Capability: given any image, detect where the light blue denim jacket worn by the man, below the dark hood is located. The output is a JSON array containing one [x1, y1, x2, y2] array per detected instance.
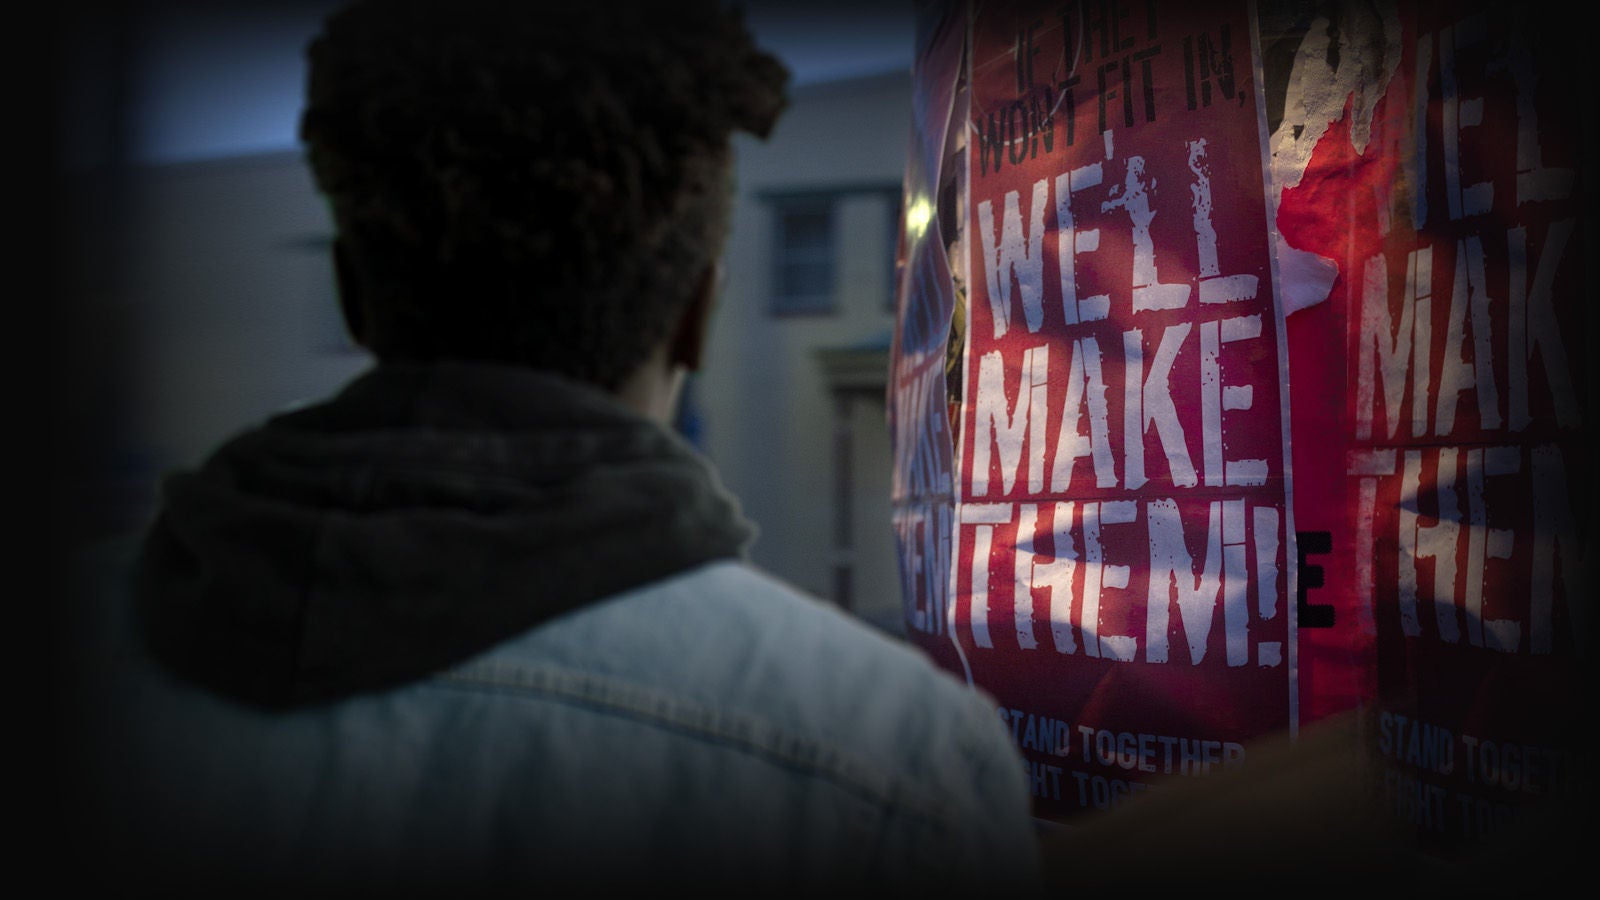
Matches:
[[75, 531, 1038, 895]]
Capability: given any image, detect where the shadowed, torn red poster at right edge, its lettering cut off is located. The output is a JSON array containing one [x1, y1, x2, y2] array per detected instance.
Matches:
[[1274, 3, 1595, 850]]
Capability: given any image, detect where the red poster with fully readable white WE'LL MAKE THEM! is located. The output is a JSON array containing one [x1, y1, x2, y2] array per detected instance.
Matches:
[[896, 2, 1298, 818]]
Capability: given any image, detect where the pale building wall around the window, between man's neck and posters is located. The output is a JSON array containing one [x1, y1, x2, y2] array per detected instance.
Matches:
[[701, 70, 910, 630]]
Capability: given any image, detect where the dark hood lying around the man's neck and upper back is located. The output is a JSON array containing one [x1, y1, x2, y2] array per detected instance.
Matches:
[[136, 364, 754, 708]]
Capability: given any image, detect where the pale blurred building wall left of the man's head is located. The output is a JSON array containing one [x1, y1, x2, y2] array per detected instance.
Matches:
[[117, 154, 370, 466]]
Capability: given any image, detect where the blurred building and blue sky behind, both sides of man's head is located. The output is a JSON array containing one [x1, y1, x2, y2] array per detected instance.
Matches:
[[46, 0, 915, 633]]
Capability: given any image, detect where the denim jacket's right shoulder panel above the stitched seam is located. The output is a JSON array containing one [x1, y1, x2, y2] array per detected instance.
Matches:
[[467, 560, 997, 761]]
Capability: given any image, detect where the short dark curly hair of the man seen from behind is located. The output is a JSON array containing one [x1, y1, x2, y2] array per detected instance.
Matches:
[[299, 0, 789, 389]]
